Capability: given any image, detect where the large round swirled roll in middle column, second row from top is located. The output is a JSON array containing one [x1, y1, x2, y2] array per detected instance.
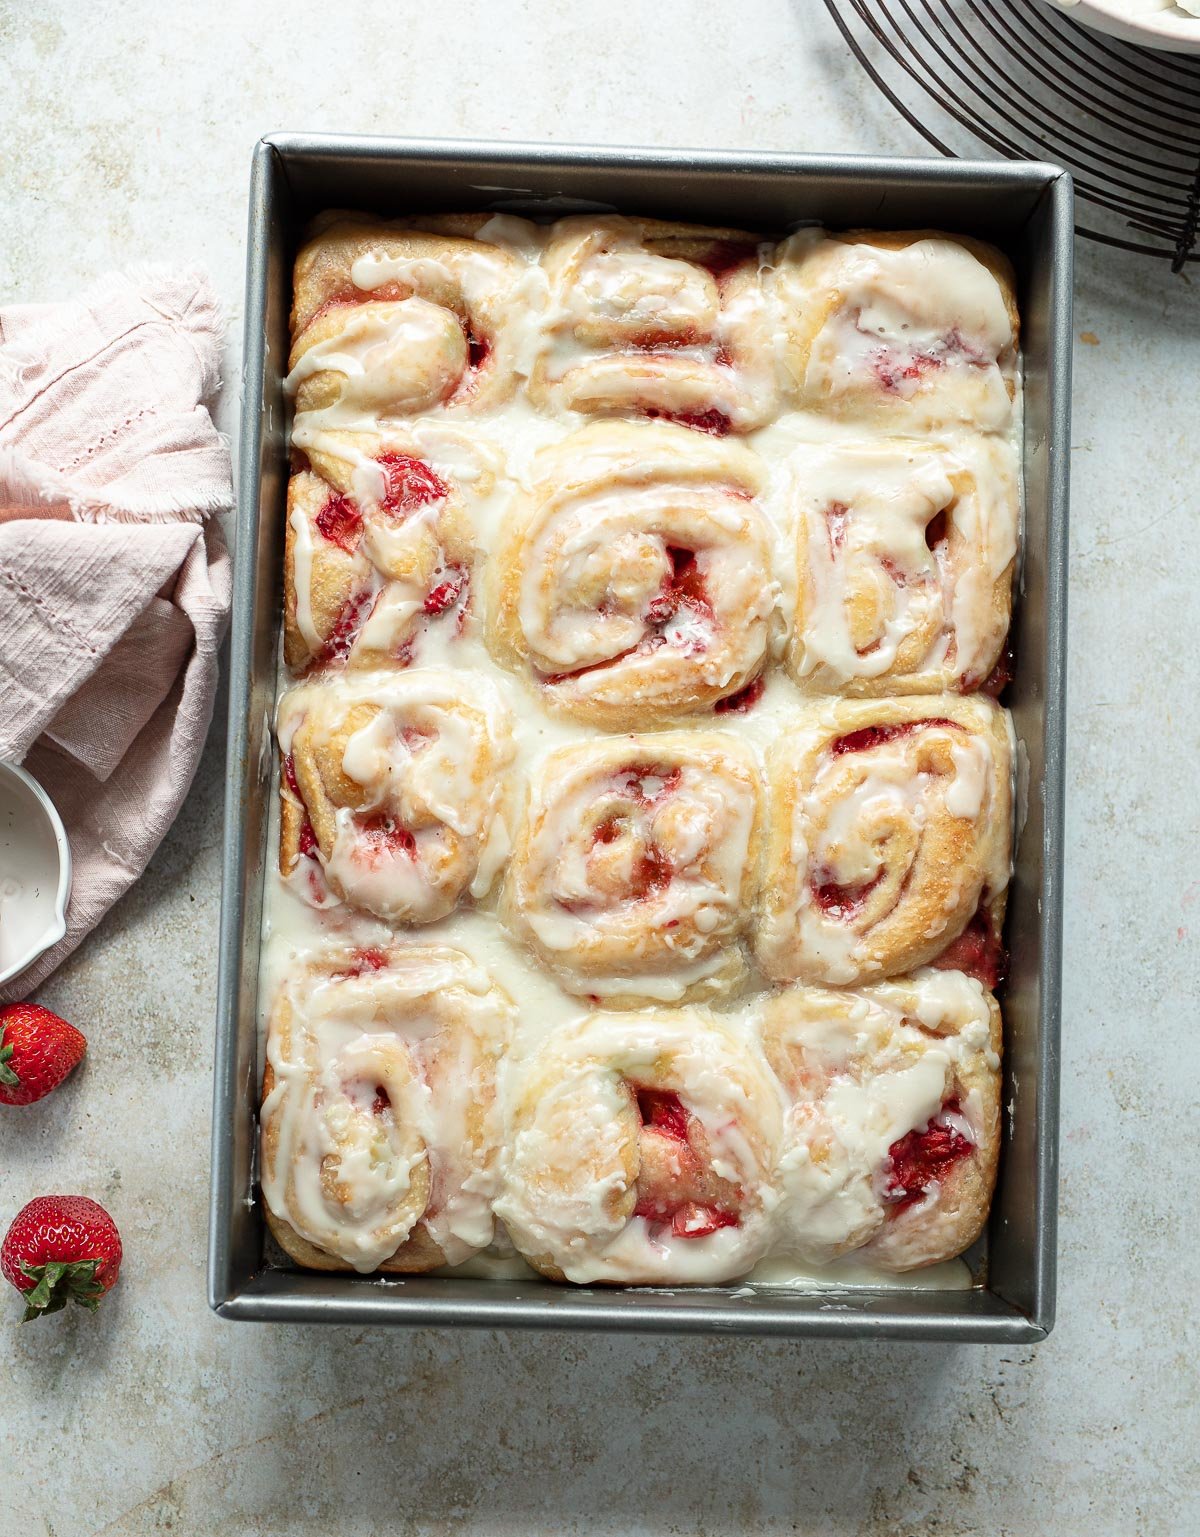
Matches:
[[489, 423, 779, 730]]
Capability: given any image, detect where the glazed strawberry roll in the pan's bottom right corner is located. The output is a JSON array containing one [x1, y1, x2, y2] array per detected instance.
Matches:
[[762, 971, 1000, 1271]]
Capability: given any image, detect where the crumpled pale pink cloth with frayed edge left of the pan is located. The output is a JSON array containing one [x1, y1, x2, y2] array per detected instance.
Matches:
[[0, 269, 234, 1001]]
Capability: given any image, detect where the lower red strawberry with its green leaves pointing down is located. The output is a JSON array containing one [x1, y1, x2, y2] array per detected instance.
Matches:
[[0, 1196, 121, 1323]]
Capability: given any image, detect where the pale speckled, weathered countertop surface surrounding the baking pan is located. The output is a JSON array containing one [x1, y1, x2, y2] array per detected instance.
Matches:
[[0, 0, 1200, 1537]]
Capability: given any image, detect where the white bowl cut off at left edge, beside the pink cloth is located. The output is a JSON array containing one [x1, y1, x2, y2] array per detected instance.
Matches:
[[0, 762, 71, 982]]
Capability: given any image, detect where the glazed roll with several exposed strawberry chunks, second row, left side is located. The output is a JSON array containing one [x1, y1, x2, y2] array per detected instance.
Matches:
[[284, 432, 473, 672]]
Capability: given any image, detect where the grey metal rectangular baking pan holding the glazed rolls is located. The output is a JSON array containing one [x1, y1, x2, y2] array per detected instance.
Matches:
[[209, 134, 1072, 1343]]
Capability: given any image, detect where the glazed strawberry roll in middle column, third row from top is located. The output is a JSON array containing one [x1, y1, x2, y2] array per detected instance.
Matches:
[[501, 732, 759, 1004]]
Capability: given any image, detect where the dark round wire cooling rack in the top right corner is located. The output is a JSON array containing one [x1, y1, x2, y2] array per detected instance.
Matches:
[[825, 0, 1200, 272]]
